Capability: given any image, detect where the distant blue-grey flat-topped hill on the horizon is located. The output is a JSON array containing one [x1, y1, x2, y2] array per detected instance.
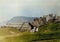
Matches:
[[7, 16, 35, 24]]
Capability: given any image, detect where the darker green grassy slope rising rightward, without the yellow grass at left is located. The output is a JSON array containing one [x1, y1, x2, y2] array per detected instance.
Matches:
[[6, 23, 60, 42]]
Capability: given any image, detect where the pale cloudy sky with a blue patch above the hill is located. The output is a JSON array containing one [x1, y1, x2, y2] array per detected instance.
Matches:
[[0, 0, 60, 23]]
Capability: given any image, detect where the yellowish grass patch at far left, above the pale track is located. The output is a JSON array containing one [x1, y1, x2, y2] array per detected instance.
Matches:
[[0, 28, 19, 36]]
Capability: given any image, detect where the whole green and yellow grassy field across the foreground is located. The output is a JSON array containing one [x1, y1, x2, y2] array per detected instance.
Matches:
[[0, 23, 60, 42]]
